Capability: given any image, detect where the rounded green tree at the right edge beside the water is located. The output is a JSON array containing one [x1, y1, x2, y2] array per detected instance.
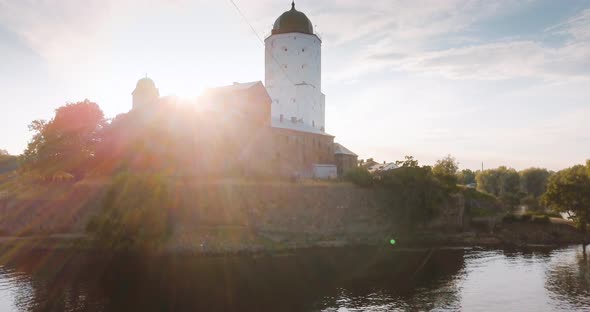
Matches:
[[542, 163, 590, 250]]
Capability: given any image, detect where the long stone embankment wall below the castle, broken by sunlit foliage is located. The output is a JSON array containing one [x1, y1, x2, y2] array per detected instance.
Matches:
[[0, 180, 463, 237]]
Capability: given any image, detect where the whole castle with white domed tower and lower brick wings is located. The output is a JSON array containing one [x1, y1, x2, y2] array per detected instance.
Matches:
[[132, 2, 357, 178]]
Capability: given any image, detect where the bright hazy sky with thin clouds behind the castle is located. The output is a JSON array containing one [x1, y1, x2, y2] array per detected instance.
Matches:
[[0, 0, 590, 170]]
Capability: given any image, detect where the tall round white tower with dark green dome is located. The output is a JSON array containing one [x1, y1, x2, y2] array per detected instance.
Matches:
[[264, 2, 325, 132]]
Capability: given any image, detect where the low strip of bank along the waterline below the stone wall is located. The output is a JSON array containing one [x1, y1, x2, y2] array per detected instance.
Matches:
[[0, 220, 584, 255]]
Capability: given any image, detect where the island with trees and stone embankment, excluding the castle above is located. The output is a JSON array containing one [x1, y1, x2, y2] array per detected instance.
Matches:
[[0, 100, 590, 253]]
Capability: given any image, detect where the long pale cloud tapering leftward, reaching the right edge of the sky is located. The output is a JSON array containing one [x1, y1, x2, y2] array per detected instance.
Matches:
[[390, 41, 590, 80]]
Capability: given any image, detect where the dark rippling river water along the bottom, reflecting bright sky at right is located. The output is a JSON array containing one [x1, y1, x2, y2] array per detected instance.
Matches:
[[0, 246, 590, 312]]
